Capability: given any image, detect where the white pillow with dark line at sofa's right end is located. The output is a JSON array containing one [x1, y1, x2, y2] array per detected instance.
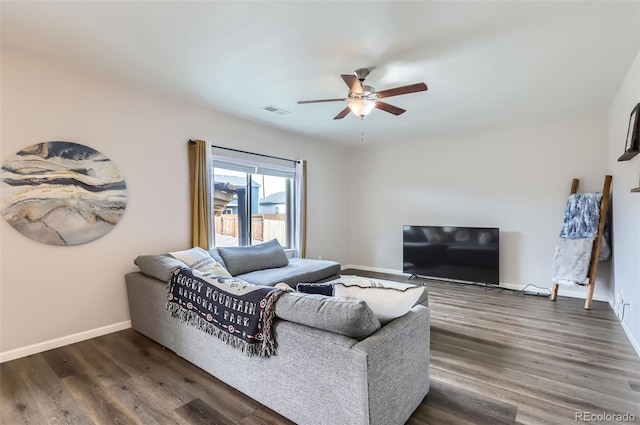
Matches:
[[333, 278, 424, 324]]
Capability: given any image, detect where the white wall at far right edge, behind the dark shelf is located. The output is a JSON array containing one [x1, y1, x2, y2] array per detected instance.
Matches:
[[609, 48, 640, 354]]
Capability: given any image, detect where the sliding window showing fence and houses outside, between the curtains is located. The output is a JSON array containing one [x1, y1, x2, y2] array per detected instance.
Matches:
[[211, 151, 303, 255]]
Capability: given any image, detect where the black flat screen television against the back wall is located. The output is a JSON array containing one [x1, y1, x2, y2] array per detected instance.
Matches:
[[402, 225, 500, 285]]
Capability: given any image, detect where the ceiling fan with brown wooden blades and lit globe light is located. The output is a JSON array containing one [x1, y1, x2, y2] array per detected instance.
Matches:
[[298, 68, 427, 120]]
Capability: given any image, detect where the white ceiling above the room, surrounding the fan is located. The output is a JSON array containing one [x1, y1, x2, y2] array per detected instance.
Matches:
[[0, 0, 640, 144]]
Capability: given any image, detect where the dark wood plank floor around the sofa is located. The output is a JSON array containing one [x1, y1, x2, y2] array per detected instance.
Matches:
[[0, 270, 640, 425]]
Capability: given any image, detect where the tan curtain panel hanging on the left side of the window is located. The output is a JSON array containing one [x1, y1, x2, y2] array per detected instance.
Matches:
[[188, 140, 212, 249]]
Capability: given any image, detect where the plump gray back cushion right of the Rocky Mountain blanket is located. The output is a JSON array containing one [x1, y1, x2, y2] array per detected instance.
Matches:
[[275, 292, 381, 340]]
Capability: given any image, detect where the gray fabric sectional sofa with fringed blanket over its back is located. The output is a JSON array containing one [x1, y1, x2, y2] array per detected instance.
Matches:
[[125, 242, 430, 425]]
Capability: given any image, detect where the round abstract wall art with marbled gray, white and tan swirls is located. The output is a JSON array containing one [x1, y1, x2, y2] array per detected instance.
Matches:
[[0, 142, 127, 245]]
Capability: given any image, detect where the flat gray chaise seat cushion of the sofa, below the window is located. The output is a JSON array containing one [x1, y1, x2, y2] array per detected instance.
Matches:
[[234, 258, 340, 288]]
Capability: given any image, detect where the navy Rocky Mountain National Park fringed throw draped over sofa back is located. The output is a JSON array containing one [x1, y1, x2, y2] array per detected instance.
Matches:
[[167, 267, 286, 356]]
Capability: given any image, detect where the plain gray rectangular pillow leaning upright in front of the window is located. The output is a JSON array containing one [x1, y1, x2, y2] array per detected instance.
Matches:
[[218, 239, 289, 276]]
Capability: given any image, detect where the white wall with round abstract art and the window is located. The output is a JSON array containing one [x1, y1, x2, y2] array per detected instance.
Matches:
[[0, 50, 348, 360]]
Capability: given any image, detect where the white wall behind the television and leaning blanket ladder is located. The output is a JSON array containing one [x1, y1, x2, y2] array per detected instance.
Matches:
[[349, 111, 610, 300]]
